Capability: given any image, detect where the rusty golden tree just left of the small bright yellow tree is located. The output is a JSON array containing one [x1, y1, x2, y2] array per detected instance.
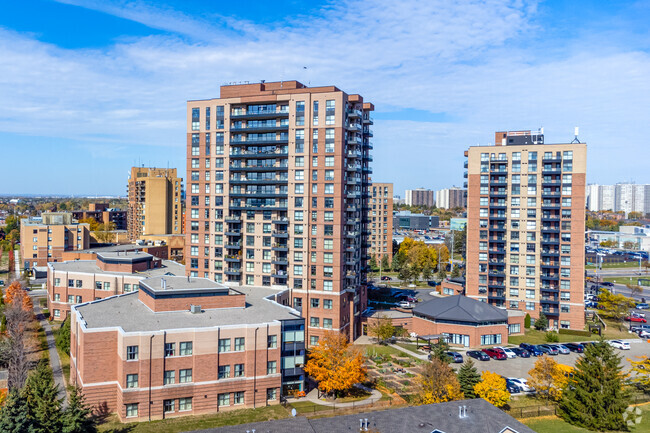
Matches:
[[418, 358, 463, 404]]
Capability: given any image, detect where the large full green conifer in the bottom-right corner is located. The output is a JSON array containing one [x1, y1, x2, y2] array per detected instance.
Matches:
[[558, 340, 629, 431]]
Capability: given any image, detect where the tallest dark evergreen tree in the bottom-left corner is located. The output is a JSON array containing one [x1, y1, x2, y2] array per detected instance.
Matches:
[[23, 361, 63, 433]]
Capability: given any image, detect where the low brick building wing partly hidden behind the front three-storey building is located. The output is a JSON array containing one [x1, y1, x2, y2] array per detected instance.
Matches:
[[46, 248, 185, 320]]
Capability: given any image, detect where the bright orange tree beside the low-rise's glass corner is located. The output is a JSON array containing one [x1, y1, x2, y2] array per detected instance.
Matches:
[[305, 332, 366, 395]]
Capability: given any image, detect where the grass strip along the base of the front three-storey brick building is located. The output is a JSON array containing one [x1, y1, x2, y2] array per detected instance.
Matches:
[[99, 404, 290, 433]]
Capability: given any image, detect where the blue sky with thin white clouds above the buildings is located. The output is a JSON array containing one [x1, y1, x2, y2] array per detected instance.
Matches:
[[0, 0, 650, 195]]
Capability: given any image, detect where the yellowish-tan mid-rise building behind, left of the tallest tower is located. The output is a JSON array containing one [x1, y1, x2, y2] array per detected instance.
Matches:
[[127, 167, 183, 241]]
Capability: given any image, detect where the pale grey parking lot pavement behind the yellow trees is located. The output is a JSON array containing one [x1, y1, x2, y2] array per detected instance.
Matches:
[[452, 339, 650, 378]]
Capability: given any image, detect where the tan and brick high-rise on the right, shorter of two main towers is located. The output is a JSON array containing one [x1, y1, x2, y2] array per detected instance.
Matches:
[[465, 131, 587, 329]]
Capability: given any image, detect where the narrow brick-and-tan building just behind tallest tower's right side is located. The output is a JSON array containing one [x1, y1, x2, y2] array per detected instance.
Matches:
[[368, 182, 393, 263]]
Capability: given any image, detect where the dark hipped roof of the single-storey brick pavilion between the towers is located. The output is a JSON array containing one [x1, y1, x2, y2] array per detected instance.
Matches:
[[413, 295, 508, 323]]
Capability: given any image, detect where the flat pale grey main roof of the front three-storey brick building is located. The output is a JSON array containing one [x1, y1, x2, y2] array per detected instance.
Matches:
[[73, 287, 300, 332]]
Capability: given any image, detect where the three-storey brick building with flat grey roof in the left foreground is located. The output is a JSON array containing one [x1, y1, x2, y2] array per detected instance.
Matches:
[[70, 276, 305, 421]]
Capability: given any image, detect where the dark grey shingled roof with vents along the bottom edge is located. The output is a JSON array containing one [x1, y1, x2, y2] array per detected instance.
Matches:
[[194, 399, 535, 433]]
